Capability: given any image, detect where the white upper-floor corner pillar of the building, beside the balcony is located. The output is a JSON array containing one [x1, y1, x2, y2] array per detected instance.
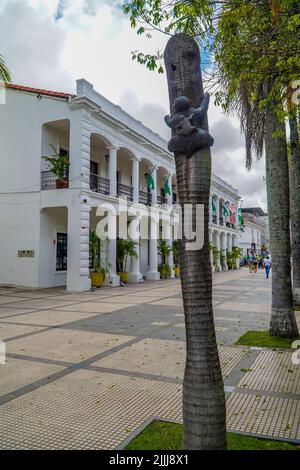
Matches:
[[69, 111, 91, 190]]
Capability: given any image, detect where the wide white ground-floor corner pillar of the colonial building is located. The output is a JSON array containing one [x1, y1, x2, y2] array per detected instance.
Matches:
[[67, 200, 91, 292]]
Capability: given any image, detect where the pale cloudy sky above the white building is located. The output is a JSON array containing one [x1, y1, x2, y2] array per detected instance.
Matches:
[[0, 0, 266, 209]]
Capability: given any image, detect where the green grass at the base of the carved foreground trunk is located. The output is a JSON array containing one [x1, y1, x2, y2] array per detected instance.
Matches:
[[125, 421, 300, 450]]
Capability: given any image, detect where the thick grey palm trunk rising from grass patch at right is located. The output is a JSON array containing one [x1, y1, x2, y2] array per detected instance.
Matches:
[[265, 83, 298, 338]]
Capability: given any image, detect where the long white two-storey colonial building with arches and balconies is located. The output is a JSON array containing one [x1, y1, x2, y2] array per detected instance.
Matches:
[[0, 79, 239, 291]]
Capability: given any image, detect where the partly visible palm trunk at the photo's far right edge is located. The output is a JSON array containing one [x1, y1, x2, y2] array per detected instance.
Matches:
[[289, 116, 300, 305]]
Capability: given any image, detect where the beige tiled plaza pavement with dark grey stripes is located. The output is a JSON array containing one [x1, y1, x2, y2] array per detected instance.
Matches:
[[0, 270, 300, 449]]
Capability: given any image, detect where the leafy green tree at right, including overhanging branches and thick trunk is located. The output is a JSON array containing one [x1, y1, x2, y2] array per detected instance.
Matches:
[[125, 0, 300, 337]]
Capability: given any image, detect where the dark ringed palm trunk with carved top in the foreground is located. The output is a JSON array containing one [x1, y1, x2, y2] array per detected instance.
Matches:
[[165, 33, 226, 450]]
